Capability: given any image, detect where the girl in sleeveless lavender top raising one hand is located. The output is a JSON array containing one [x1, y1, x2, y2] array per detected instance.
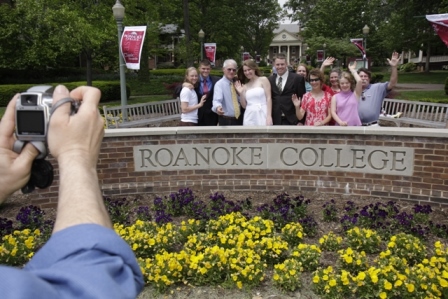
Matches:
[[331, 61, 362, 126]]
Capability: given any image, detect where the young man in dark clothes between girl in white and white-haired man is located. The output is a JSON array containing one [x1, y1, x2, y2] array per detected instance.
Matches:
[[194, 59, 220, 126]]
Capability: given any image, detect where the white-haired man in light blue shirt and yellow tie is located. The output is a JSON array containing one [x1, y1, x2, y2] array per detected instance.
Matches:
[[212, 59, 243, 126]]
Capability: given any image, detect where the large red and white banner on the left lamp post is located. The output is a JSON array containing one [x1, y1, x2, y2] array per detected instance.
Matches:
[[120, 26, 146, 70]]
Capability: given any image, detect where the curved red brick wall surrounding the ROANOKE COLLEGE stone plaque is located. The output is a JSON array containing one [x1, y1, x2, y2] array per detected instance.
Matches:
[[32, 127, 448, 208]]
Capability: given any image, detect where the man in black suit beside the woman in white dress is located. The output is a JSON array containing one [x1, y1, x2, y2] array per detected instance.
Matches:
[[269, 53, 306, 126]]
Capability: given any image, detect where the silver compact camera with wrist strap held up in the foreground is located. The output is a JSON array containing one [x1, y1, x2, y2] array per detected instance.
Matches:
[[13, 86, 80, 193]]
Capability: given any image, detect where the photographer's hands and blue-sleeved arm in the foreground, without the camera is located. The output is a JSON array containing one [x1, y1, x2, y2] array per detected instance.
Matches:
[[0, 85, 143, 299]]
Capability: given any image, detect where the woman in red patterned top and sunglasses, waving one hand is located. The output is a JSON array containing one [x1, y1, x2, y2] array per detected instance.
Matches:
[[292, 69, 331, 126]]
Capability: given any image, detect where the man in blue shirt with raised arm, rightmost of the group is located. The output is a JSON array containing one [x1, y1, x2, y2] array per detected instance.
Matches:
[[358, 52, 400, 126]]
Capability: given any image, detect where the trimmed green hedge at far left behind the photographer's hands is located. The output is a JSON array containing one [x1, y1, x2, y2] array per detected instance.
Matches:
[[0, 81, 131, 107]]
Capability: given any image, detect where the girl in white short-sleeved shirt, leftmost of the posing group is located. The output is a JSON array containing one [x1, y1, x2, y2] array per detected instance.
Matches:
[[179, 67, 207, 126]]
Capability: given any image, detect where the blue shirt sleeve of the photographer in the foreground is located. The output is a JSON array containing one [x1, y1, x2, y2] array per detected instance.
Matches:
[[0, 224, 144, 299]]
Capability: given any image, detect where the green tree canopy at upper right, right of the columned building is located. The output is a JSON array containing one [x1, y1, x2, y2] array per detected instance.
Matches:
[[285, 0, 448, 63]]
